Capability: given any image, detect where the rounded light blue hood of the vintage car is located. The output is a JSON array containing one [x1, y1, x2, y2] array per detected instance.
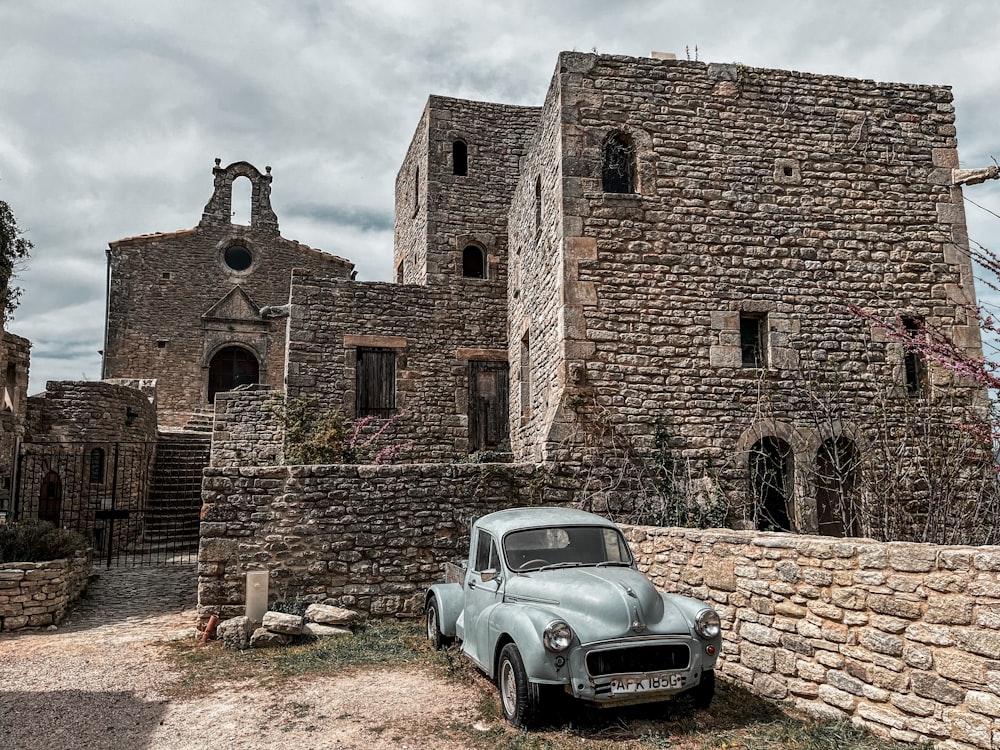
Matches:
[[504, 567, 690, 643]]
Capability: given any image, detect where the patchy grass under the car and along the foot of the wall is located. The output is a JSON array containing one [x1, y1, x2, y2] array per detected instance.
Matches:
[[164, 620, 914, 750]]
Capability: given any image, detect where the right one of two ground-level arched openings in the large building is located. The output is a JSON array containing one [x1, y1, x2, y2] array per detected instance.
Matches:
[[816, 437, 860, 536]]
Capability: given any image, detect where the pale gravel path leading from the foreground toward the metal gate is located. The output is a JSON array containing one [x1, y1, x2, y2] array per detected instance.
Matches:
[[0, 565, 488, 750]]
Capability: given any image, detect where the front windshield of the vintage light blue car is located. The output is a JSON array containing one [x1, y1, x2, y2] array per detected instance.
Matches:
[[503, 526, 632, 573]]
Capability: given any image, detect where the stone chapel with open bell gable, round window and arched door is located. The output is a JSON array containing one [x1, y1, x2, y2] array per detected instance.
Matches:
[[102, 159, 353, 427]]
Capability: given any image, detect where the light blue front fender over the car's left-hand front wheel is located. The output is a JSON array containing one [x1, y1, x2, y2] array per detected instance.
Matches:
[[483, 603, 575, 683]]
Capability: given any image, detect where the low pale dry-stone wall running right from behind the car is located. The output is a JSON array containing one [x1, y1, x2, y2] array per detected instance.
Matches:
[[626, 527, 1000, 750]]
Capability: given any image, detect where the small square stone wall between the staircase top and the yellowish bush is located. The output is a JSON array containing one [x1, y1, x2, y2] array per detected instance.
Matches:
[[211, 389, 285, 466]]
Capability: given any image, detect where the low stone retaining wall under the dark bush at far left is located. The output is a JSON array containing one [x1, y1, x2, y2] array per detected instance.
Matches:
[[0, 552, 91, 631]]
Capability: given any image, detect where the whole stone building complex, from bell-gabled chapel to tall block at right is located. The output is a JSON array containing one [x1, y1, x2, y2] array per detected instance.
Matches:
[[97, 52, 984, 534]]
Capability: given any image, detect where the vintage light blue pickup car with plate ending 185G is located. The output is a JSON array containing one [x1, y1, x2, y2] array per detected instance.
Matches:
[[425, 508, 722, 727]]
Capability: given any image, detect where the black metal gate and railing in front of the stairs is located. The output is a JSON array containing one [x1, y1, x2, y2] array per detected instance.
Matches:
[[13, 442, 200, 567]]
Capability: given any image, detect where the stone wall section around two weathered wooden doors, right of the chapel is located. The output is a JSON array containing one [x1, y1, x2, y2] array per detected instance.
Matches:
[[287, 271, 507, 462]]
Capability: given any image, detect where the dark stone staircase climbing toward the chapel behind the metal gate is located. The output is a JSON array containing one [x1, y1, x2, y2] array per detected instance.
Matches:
[[143, 430, 211, 555]]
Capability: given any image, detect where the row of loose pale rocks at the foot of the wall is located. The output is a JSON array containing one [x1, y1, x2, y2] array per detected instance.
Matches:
[[215, 604, 358, 649]]
